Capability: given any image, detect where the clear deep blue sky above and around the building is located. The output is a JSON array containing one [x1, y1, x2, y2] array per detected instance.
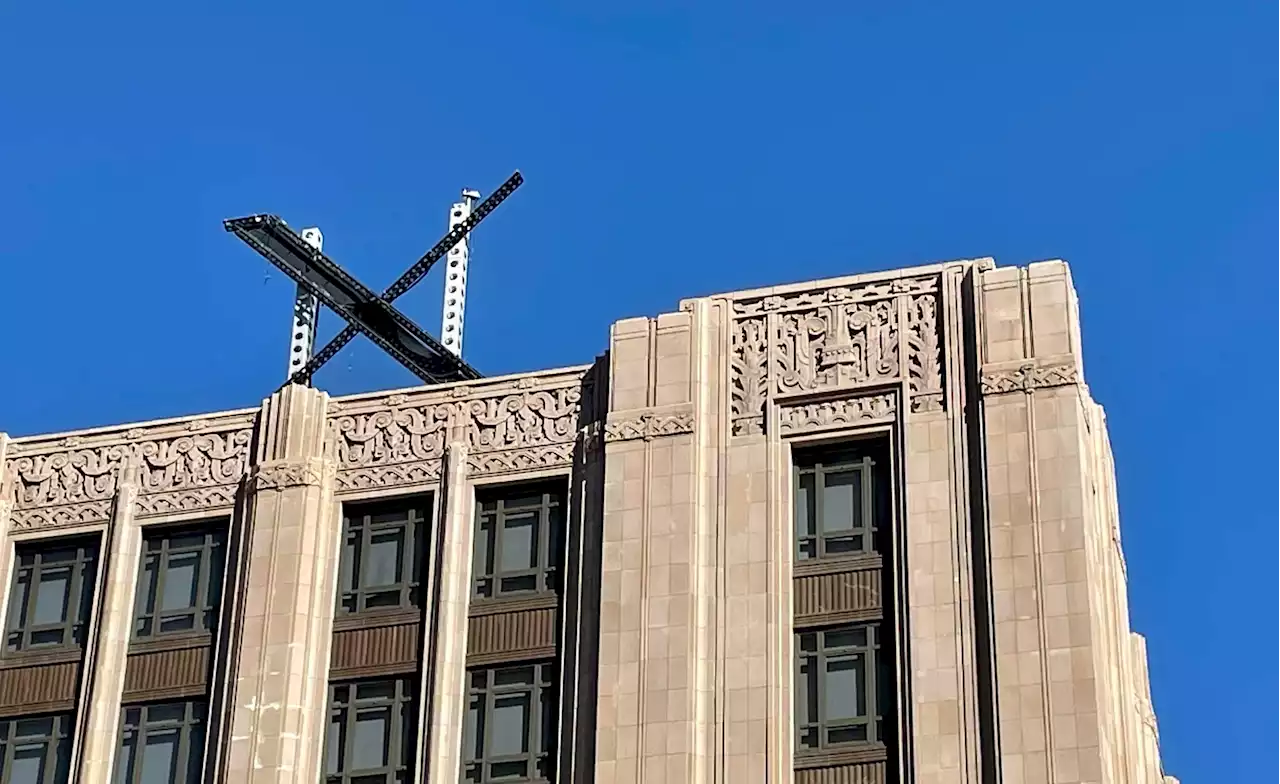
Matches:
[[0, 0, 1280, 784]]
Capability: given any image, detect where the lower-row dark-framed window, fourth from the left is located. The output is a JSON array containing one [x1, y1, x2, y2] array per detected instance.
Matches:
[[462, 661, 557, 784]]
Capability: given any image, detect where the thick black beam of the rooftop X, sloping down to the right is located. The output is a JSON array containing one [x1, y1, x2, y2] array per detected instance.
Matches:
[[223, 215, 480, 384]]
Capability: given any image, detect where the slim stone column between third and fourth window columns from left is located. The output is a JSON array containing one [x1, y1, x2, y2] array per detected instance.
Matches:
[[422, 442, 475, 781]]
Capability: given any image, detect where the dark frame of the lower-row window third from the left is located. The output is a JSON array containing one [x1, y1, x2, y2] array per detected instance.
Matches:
[[320, 675, 420, 784]]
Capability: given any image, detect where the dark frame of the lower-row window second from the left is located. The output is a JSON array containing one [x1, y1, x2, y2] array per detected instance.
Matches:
[[111, 698, 209, 784]]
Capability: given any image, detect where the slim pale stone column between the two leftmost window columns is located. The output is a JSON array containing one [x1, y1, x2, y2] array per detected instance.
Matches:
[[78, 464, 142, 784]]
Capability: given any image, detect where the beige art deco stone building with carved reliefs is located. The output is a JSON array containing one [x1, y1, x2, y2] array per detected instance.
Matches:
[[0, 260, 1171, 784]]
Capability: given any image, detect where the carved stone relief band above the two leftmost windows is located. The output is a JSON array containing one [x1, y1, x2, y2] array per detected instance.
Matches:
[[5, 411, 256, 529]]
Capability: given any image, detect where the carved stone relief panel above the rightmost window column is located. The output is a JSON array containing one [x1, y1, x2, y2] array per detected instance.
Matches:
[[730, 275, 943, 436]]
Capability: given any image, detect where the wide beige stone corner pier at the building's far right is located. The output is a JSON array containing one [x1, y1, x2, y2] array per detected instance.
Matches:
[[982, 261, 1141, 784]]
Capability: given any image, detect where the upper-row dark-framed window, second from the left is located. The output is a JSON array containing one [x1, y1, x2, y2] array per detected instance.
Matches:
[[133, 528, 227, 639]]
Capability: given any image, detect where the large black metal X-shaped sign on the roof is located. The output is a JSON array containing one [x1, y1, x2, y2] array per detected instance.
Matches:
[[223, 172, 525, 384]]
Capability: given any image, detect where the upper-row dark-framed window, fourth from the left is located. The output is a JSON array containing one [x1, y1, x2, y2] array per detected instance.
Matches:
[[472, 487, 564, 598]]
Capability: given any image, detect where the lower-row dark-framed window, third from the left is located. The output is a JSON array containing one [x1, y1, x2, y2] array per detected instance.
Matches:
[[325, 678, 417, 784]]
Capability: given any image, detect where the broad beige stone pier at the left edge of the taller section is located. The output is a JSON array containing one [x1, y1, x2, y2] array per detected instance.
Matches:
[[596, 313, 717, 784]]
